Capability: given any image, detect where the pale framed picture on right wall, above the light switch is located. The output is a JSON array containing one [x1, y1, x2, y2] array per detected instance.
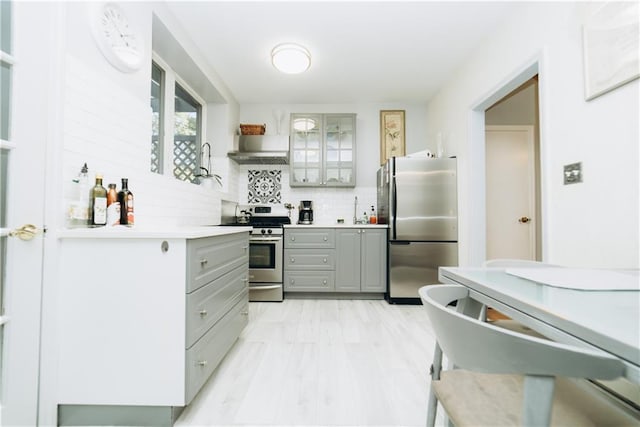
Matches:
[[583, 2, 640, 101]]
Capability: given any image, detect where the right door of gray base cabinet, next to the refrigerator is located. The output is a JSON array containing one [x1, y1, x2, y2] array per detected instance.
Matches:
[[360, 229, 387, 292]]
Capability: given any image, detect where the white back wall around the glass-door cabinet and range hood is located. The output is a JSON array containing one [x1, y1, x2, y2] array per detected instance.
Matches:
[[232, 104, 428, 224]]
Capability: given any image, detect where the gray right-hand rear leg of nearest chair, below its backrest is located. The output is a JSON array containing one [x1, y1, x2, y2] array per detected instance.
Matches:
[[522, 375, 556, 426]]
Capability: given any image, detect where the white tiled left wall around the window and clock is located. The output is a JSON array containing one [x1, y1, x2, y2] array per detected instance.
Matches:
[[57, 3, 237, 231]]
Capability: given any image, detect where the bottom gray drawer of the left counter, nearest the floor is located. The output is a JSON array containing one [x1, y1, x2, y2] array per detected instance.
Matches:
[[185, 291, 249, 404]]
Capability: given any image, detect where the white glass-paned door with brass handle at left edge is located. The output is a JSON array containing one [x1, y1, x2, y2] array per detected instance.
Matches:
[[0, 1, 48, 426]]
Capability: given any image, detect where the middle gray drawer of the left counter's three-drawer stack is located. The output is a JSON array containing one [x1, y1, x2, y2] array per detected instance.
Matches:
[[185, 264, 248, 348]]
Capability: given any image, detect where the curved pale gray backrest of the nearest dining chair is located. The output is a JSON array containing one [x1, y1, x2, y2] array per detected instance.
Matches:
[[419, 285, 625, 379]]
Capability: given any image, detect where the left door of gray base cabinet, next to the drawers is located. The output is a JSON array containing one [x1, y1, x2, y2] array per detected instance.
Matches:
[[336, 228, 361, 292]]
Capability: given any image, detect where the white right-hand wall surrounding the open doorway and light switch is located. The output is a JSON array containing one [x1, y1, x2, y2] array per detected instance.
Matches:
[[426, 2, 640, 268]]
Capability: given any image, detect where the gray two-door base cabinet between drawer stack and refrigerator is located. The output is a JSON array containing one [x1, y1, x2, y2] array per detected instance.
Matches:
[[336, 228, 387, 292]]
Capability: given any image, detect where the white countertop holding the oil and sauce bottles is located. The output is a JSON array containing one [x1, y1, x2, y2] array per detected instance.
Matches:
[[58, 225, 252, 239]]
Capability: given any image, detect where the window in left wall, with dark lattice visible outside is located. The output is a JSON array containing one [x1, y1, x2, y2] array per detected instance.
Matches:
[[150, 62, 203, 184]]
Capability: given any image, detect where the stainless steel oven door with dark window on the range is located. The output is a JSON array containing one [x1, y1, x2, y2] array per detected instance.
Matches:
[[249, 236, 282, 283]]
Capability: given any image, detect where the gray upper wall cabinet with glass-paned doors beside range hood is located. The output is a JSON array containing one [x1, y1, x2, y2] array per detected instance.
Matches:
[[290, 113, 356, 187]]
